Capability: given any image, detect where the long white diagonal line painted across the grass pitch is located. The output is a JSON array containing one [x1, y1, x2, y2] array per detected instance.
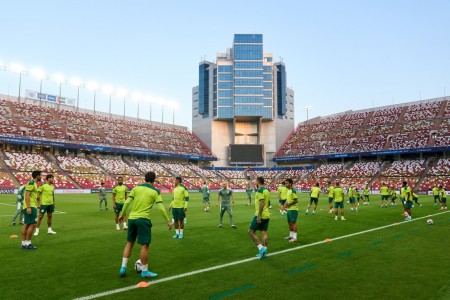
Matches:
[[74, 211, 450, 300]]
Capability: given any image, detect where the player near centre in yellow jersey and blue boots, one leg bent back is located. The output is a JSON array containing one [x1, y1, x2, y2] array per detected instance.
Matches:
[[248, 177, 270, 259]]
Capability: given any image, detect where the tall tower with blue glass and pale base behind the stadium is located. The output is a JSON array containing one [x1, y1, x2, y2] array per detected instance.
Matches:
[[192, 34, 294, 165]]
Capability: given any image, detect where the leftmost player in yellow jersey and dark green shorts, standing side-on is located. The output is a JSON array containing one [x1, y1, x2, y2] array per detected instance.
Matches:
[[21, 171, 41, 250]]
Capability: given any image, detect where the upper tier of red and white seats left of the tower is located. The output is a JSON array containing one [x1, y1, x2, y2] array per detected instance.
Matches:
[[0, 100, 212, 159]]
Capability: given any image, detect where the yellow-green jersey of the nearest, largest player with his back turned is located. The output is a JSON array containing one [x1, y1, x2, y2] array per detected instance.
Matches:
[[123, 183, 167, 221]]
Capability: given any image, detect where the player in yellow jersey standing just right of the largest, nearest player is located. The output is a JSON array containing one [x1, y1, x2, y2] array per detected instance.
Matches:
[[172, 177, 189, 239]]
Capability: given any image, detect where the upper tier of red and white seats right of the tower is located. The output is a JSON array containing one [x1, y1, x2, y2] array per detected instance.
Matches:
[[275, 99, 450, 157]]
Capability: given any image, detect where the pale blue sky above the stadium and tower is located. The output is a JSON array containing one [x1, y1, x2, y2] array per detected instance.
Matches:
[[0, 0, 450, 127]]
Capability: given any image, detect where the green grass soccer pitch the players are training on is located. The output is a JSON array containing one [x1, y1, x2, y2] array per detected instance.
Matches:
[[0, 193, 450, 299]]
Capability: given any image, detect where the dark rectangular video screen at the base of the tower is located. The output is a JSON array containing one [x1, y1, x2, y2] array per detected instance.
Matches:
[[230, 144, 264, 165]]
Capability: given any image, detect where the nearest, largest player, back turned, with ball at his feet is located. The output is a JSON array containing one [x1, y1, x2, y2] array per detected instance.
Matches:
[[119, 172, 172, 278]]
